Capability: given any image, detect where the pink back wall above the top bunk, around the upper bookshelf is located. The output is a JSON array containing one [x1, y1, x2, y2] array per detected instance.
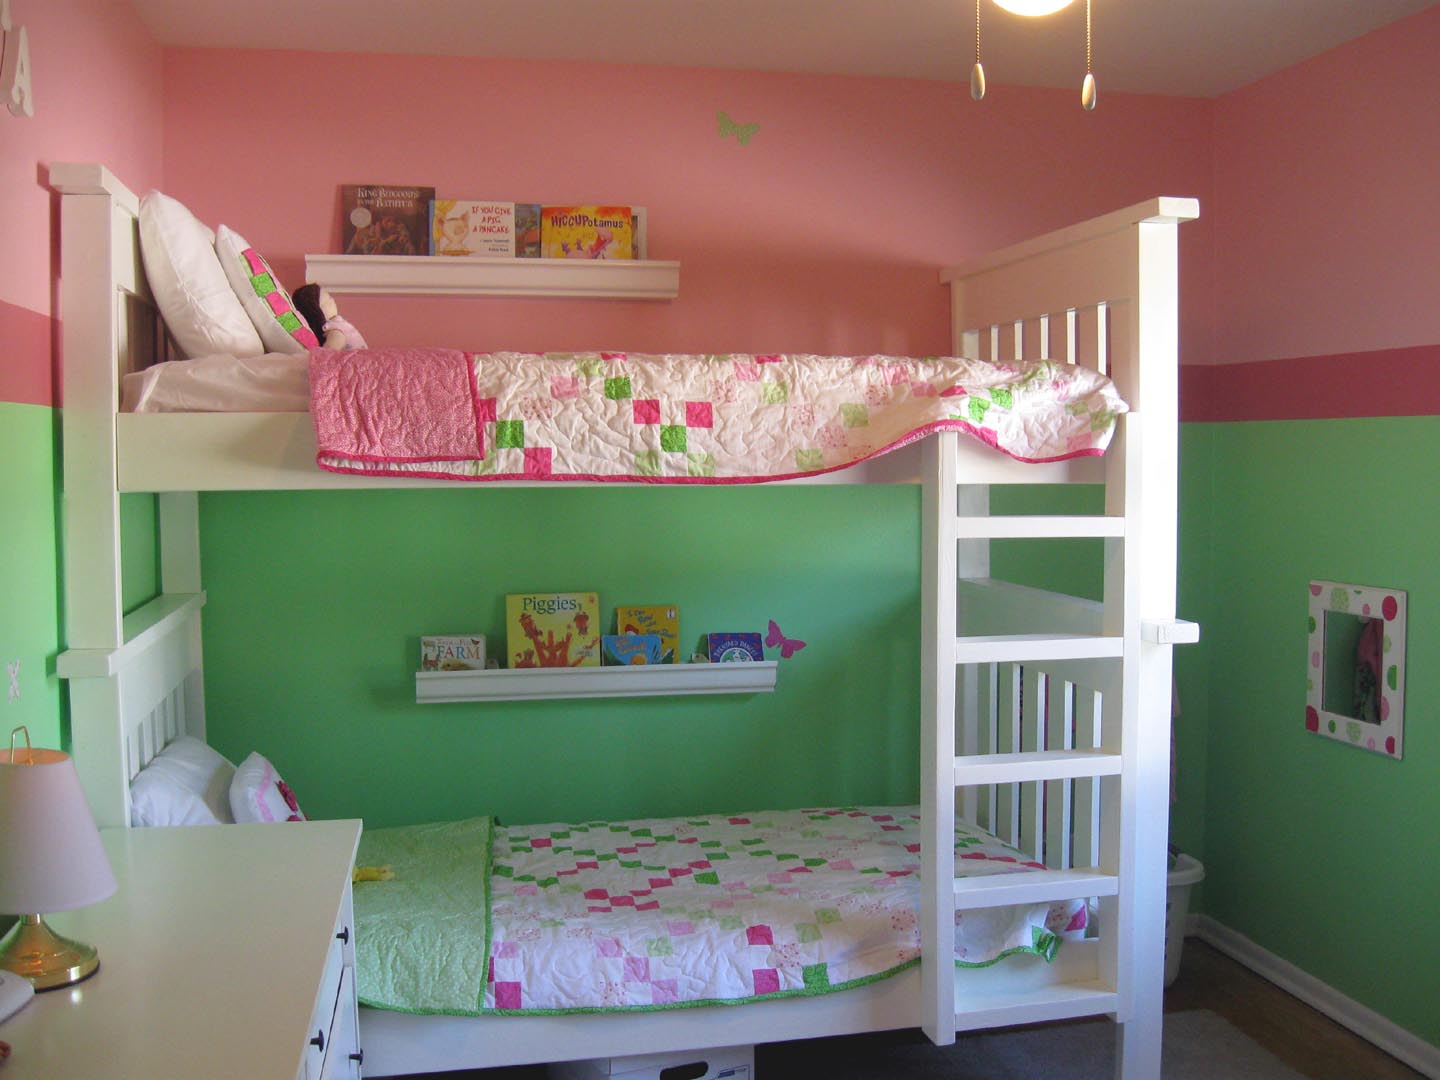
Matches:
[[164, 49, 1211, 360]]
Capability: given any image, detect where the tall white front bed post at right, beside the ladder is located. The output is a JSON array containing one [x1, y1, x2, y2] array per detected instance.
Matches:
[[1102, 207, 1194, 1080]]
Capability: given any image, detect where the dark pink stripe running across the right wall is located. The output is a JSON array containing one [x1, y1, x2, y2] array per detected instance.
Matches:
[[1179, 344, 1440, 422]]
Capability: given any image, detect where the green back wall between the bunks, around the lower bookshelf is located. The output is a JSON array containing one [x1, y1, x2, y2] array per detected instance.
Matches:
[[202, 485, 919, 827]]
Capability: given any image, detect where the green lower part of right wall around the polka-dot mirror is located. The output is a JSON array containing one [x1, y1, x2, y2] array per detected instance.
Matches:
[[1182, 416, 1440, 1044]]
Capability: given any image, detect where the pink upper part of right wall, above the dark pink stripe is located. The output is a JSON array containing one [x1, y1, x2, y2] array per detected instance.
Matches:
[[1214, 7, 1440, 364]]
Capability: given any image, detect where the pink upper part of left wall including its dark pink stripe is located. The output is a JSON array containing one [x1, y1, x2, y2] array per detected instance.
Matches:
[[0, 0, 163, 405]]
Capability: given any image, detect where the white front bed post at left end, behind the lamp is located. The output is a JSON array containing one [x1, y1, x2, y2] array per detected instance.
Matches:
[[50, 164, 131, 825]]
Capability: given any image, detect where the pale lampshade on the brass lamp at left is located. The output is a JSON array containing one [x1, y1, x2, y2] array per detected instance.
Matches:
[[0, 750, 115, 914]]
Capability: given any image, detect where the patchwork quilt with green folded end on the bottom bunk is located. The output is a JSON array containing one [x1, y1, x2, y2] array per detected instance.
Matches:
[[354, 808, 1086, 1015]]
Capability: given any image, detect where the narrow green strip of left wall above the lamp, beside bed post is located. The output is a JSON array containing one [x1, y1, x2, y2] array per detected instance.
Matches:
[[0, 402, 68, 747]]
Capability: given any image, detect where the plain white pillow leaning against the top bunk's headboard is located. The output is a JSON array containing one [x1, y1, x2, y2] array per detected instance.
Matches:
[[140, 192, 265, 357]]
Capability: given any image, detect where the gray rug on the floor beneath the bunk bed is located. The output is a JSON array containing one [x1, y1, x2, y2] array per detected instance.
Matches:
[[755, 1009, 1305, 1080]]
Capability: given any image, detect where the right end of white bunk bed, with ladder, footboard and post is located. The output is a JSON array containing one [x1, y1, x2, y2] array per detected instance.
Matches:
[[920, 199, 1198, 1080]]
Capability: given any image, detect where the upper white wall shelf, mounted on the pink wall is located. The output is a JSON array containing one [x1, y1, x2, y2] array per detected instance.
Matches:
[[305, 255, 680, 300]]
